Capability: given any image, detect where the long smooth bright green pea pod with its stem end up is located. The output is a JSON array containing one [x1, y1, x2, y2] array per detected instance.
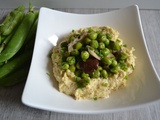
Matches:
[[0, 12, 35, 63]]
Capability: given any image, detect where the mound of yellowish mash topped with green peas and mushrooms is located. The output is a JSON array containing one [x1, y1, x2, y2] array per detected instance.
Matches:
[[51, 26, 136, 100]]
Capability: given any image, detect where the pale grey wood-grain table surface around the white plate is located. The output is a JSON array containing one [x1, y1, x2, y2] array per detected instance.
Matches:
[[0, 8, 160, 120]]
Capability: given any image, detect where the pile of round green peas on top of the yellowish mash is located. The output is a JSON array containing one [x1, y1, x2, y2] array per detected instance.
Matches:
[[60, 28, 127, 87]]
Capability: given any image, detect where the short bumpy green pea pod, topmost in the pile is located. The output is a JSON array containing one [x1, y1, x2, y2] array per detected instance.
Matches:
[[0, 6, 25, 36]]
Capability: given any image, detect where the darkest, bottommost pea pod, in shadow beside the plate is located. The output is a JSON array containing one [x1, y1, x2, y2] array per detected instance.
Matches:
[[0, 66, 29, 87]]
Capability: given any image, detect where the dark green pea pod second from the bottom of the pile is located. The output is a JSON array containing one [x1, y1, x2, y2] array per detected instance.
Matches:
[[0, 51, 32, 81]]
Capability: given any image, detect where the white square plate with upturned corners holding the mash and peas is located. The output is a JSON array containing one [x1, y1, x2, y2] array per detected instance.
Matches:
[[22, 5, 160, 114]]
